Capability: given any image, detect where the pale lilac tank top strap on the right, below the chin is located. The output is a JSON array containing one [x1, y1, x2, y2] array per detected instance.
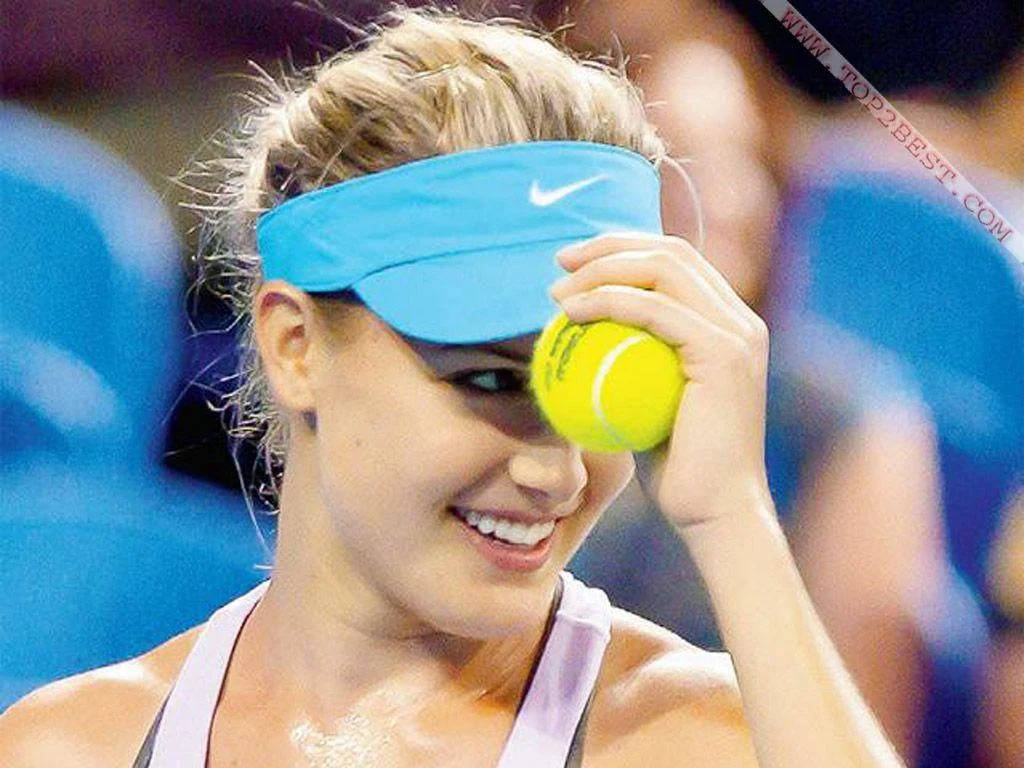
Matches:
[[499, 570, 611, 768]]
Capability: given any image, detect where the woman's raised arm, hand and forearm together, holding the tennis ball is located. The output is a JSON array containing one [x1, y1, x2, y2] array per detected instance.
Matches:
[[553, 233, 903, 768]]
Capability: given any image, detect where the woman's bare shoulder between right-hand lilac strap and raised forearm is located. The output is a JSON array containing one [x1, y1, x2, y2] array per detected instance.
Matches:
[[584, 607, 757, 768]]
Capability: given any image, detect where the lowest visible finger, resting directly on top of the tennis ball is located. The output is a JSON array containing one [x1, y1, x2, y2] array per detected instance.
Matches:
[[561, 286, 743, 366]]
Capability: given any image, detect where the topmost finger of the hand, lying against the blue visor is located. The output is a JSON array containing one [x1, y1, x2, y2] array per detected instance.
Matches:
[[557, 231, 765, 337]]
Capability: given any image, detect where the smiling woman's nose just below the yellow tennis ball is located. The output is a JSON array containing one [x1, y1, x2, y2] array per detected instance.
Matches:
[[509, 438, 588, 513]]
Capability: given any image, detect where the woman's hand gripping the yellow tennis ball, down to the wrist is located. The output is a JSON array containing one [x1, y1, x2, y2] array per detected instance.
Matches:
[[551, 232, 768, 532]]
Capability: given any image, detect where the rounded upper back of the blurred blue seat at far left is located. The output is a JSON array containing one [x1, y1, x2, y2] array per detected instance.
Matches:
[[0, 103, 185, 463]]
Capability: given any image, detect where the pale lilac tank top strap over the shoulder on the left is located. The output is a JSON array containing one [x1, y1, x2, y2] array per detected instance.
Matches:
[[148, 580, 270, 768]]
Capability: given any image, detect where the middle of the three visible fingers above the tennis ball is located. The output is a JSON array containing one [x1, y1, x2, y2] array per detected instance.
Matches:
[[551, 250, 746, 335]]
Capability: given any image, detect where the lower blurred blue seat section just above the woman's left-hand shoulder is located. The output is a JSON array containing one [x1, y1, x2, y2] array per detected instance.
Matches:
[[0, 453, 267, 711]]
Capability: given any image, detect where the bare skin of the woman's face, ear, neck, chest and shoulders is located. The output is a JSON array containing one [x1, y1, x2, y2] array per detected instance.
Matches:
[[0, 237, 754, 766]]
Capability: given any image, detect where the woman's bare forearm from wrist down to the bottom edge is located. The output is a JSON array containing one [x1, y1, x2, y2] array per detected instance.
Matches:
[[681, 492, 903, 768]]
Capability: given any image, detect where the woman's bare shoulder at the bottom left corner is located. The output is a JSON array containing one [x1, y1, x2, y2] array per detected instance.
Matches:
[[0, 625, 204, 768]]
